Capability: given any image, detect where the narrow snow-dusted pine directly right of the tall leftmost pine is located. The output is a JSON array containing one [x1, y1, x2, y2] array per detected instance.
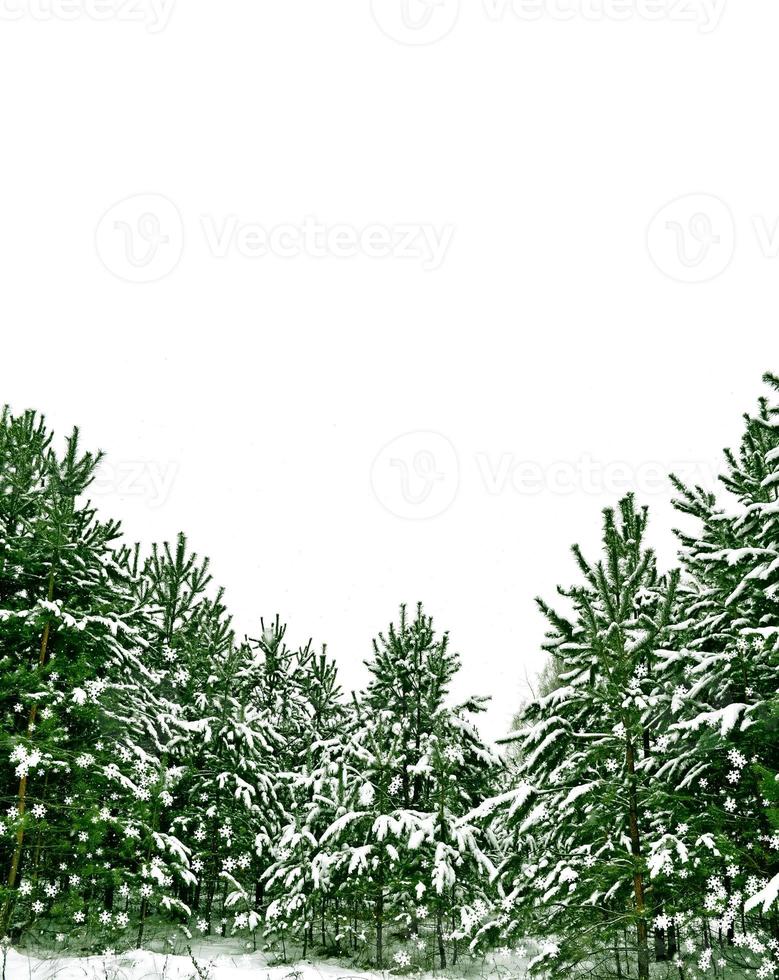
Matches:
[[94, 534, 224, 945]]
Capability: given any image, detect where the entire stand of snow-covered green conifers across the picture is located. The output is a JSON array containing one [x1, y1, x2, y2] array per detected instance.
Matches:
[[0, 375, 779, 980]]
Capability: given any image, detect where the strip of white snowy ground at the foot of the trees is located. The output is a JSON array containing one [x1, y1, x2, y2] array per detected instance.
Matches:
[[0, 943, 525, 980]]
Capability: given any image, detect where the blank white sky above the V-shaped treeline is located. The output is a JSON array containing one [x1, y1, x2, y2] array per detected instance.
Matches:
[[0, 0, 779, 738]]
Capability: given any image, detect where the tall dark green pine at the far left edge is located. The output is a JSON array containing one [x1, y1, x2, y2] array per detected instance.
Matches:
[[0, 412, 155, 933]]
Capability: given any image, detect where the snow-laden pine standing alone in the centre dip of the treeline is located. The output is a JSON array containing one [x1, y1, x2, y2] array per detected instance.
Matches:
[[317, 605, 497, 965]]
